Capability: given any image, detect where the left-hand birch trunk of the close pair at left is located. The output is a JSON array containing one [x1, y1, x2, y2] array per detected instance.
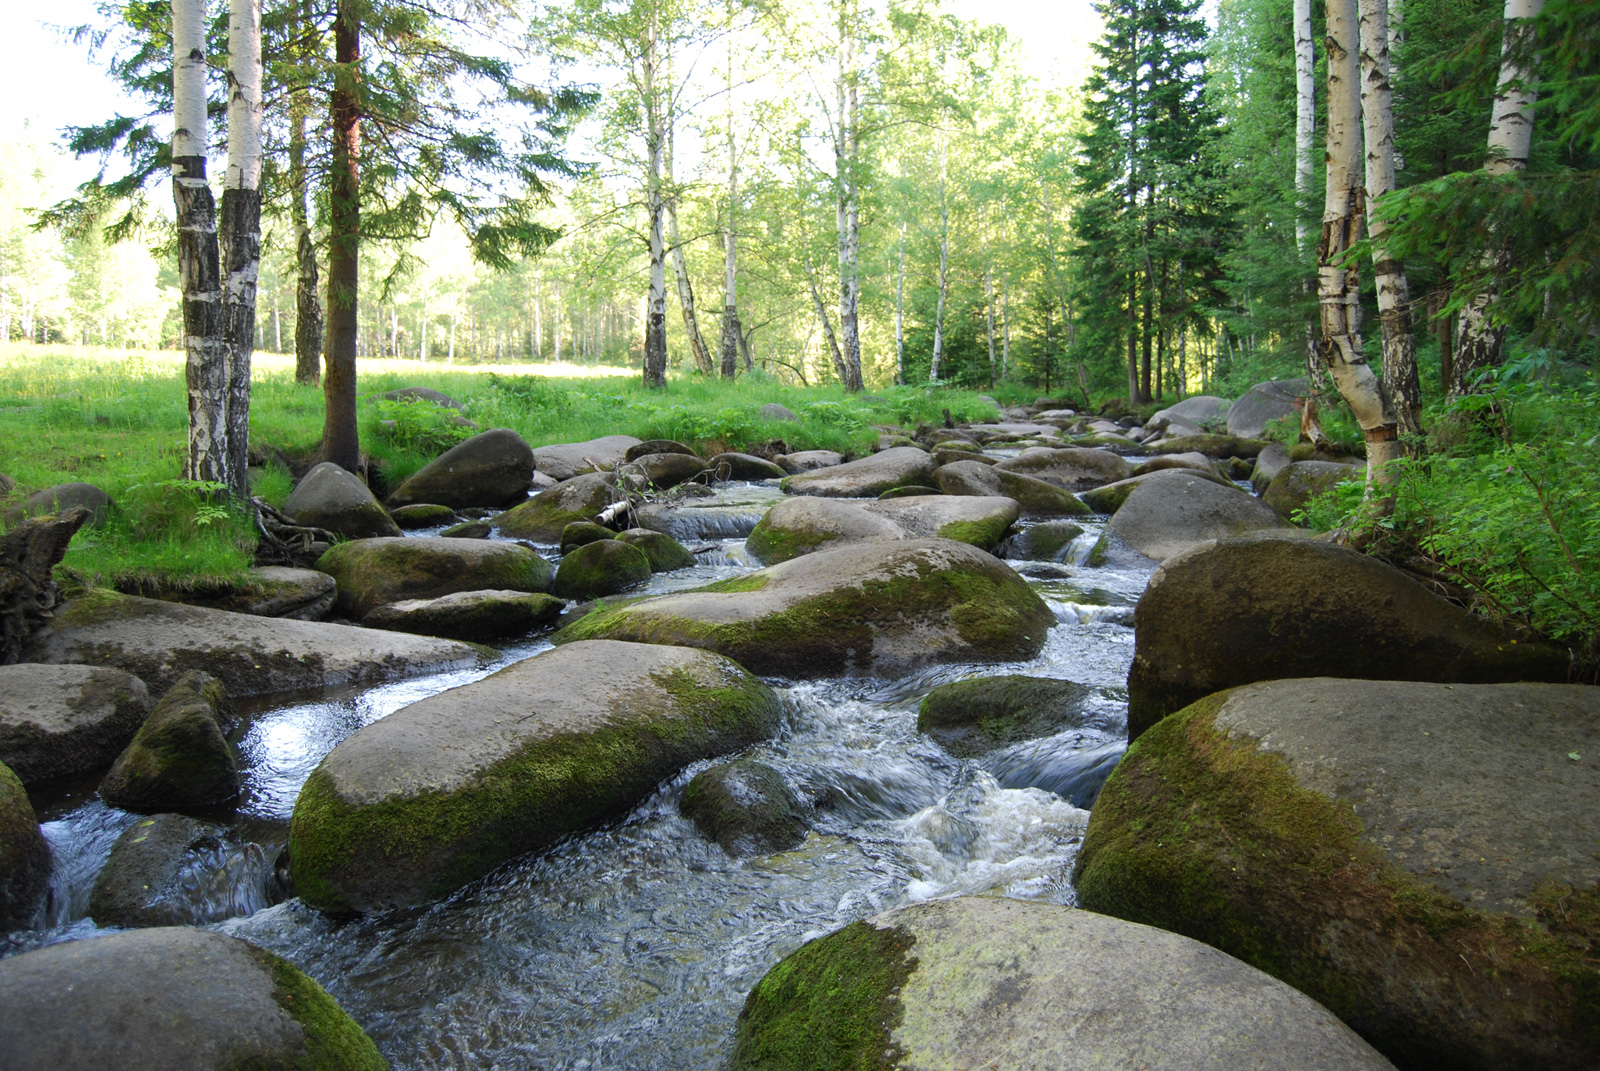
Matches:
[[173, 0, 230, 487]]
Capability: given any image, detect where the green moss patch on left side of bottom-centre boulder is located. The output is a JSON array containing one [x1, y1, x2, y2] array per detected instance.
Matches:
[[730, 922, 917, 1071]]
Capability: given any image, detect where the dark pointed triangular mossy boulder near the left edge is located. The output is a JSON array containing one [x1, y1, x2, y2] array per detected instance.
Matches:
[[99, 669, 240, 815]]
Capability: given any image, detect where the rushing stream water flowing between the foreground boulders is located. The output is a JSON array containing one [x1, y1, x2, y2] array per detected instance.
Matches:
[[0, 485, 1150, 1069]]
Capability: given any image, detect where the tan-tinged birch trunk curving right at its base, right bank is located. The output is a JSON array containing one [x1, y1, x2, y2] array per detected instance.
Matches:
[[1317, 0, 1400, 483]]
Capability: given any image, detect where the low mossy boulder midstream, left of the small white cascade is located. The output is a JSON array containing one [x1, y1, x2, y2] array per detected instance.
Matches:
[[917, 674, 1094, 759]]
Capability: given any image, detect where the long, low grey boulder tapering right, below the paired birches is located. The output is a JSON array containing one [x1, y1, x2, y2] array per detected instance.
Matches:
[[24, 591, 478, 700]]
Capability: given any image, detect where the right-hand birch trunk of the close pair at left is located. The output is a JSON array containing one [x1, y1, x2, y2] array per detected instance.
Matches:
[[218, 0, 262, 503]]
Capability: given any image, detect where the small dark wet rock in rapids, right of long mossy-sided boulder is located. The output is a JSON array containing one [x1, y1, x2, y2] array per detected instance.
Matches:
[[680, 759, 806, 856]]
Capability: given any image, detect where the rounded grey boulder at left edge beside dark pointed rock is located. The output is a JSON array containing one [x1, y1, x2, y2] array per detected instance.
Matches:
[[0, 663, 150, 784]]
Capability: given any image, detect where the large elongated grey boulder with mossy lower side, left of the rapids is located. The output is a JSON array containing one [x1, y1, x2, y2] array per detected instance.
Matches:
[[290, 642, 779, 913]]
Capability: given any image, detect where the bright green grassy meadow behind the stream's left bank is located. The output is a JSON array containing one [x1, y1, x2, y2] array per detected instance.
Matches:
[[0, 344, 1032, 589]]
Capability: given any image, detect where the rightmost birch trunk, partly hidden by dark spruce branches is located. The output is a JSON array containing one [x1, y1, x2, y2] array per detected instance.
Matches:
[[1450, 0, 1544, 397]]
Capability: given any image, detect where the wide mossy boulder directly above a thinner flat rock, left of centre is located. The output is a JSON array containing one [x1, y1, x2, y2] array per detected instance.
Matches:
[[317, 536, 554, 618]]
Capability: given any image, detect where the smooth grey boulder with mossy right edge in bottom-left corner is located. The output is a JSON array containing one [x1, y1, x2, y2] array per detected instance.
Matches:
[[0, 927, 389, 1071]]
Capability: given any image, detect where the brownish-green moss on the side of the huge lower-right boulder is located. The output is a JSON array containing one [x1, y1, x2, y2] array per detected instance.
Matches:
[[1077, 692, 1600, 1071]]
